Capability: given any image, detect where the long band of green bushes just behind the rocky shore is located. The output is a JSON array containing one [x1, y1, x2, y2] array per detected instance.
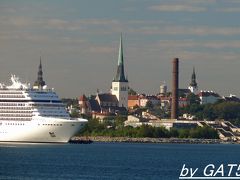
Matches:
[[79, 117, 218, 139]]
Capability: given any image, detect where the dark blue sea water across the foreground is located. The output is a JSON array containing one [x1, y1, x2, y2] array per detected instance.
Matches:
[[0, 143, 240, 180]]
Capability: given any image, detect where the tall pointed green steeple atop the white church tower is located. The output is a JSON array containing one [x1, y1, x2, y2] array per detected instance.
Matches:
[[113, 34, 128, 82]]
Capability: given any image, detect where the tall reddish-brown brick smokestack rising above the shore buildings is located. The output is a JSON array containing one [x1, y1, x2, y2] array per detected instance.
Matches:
[[171, 58, 178, 119]]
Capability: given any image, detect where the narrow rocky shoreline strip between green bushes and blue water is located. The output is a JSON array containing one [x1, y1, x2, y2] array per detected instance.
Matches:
[[71, 136, 236, 144]]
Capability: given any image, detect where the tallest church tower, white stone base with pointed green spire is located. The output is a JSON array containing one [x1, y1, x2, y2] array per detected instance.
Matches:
[[111, 35, 128, 108]]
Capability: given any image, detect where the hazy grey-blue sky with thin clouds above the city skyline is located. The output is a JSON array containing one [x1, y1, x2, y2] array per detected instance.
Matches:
[[0, 0, 240, 97]]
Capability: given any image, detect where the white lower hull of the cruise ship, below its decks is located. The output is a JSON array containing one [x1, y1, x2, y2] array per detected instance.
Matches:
[[0, 117, 87, 143]]
